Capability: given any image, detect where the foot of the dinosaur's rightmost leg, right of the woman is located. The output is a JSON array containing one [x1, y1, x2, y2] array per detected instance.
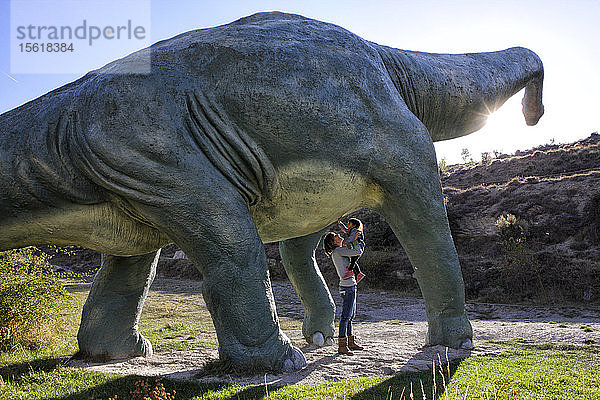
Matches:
[[427, 314, 473, 350]]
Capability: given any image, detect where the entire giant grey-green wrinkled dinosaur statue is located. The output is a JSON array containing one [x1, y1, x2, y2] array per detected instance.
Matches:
[[0, 13, 543, 370]]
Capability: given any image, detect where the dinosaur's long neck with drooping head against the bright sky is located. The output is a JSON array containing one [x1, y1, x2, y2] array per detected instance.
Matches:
[[377, 45, 544, 142]]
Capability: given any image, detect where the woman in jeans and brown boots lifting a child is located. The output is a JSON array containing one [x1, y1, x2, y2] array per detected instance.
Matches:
[[323, 232, 363, 355]]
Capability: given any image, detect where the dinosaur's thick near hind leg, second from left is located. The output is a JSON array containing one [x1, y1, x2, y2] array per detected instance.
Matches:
[[138, 184, 306, 371]]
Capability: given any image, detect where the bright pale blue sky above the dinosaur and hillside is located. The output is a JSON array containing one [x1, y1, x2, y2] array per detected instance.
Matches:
[[0, 0, 600, 162]]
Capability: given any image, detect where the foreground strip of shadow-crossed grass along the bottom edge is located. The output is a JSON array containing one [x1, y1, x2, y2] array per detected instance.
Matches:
[[0, 343, 600, 400]]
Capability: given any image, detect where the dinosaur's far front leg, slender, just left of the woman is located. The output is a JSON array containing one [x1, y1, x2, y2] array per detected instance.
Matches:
[[279, 231, 335, 346]]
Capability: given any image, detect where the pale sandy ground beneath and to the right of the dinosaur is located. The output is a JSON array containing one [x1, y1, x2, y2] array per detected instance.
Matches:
[[73, 282, 600, 384]]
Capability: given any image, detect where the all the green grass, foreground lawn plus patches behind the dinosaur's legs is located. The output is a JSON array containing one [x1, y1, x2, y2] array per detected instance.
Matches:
[[0, 276, 600, 400]]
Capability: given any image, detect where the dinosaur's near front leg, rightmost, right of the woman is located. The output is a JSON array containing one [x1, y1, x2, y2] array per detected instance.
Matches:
[[370, 124, 473, 348]]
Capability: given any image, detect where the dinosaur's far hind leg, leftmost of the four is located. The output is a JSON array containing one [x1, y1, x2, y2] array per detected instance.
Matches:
[[77, 250, 160, 359]]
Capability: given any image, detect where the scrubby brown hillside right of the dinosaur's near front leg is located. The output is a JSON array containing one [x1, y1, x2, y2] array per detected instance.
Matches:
[[442, 133, 600, 303]]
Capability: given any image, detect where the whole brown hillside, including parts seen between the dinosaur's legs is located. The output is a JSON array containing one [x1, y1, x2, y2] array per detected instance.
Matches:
[[48, 133, 600, 304]]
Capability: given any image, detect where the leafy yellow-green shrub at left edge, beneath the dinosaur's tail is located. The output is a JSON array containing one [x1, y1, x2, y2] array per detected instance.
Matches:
[[0, 247, 70, 349]]
